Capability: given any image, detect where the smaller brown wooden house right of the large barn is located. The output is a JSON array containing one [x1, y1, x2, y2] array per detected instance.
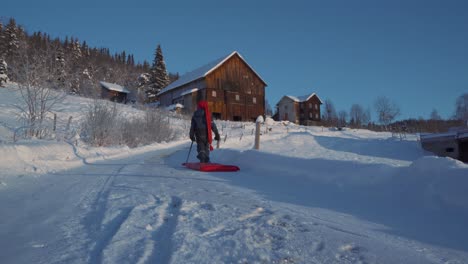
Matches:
[[276, 93, 322, 125]]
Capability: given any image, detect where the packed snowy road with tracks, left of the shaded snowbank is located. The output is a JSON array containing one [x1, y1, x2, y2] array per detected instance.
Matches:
[[0, 142, 468, 263]]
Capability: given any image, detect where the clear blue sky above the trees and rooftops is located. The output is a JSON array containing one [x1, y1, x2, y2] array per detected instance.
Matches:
[[0, 0, 468, 119]]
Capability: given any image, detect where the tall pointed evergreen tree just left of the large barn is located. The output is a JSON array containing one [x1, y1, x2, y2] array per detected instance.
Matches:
[[146, 44, 170, 102]]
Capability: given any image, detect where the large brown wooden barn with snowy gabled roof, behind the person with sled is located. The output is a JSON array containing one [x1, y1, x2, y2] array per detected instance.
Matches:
[[158, 51, 267, 121]]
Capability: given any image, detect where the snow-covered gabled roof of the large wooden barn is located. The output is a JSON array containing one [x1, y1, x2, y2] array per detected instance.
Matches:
[[158, 51, 266, 96]]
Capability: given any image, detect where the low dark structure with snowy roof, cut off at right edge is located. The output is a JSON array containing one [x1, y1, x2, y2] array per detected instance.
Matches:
[[420, 129, 468, 162]]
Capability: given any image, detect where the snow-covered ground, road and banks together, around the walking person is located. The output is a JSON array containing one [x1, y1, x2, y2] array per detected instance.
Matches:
[[0, 86, 468, 263]]
